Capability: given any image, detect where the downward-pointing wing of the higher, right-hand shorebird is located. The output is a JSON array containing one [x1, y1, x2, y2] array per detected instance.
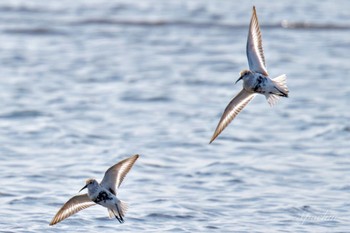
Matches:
[[210, 89, 256, 143]]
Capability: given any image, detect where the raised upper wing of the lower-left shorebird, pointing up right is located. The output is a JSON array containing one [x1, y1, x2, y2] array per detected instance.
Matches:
[[101, 154, 139, 195]]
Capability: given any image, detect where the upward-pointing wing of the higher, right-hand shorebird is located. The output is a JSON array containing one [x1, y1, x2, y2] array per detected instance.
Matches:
[[247, 7, 268, 76]]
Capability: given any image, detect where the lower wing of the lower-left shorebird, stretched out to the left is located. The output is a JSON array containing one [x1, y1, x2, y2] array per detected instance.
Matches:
[[50, 194, 95, 225]]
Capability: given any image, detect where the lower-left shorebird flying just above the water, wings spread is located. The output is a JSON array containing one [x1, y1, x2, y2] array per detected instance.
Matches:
[[50, 154, 139, 225]]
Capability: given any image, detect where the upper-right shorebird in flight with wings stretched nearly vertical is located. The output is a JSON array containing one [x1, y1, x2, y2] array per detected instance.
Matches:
[[209, 6, 289, 143]]
